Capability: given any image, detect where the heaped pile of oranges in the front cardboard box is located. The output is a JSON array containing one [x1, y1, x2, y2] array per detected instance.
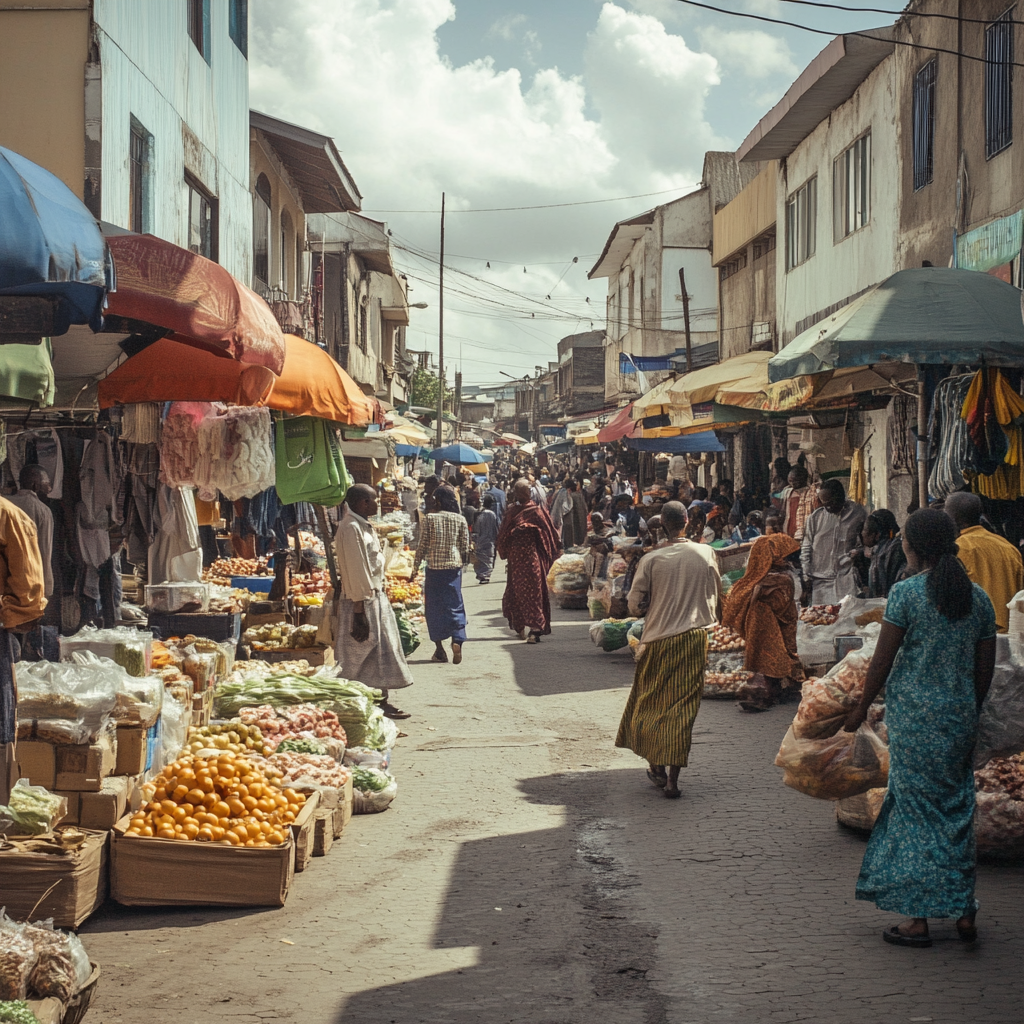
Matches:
[[126, 752, 306, 847]]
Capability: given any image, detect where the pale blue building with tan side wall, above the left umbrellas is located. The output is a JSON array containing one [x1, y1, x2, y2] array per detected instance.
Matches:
[[0, 0, 252, 281]]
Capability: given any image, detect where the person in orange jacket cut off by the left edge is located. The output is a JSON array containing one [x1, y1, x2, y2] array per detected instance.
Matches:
[[0, 498, 46, 804]]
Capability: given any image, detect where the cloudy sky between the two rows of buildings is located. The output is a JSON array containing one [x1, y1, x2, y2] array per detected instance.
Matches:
[[249, 0, 900, 384]]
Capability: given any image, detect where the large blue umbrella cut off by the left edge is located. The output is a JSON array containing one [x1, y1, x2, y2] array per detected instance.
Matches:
[[0, 146, 115, 335]]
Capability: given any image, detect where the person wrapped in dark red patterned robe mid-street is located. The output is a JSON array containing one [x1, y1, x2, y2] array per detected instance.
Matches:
[[498, 479, 560, 643]]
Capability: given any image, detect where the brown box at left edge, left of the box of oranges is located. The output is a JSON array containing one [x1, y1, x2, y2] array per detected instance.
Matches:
[[0, 831, 110, 928]]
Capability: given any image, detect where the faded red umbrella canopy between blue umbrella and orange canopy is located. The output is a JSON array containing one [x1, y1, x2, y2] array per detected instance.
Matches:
[[106, 234, 285, 374]]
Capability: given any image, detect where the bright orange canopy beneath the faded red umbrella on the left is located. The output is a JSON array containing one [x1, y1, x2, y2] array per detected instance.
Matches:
[[98, 335, 383, 427]]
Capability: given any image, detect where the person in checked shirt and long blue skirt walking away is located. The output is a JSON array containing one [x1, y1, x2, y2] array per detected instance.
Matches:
[[413, 485, 470, 665]]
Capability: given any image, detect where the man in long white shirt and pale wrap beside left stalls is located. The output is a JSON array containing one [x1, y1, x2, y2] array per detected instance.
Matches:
[[334, 483, 413, 718]]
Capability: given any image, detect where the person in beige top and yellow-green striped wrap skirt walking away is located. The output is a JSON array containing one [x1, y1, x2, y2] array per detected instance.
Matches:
[[615, 502, 722, 798]]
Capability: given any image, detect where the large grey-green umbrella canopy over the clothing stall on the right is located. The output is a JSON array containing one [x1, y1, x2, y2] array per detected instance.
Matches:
[[768, 266, 1024, 383]]
